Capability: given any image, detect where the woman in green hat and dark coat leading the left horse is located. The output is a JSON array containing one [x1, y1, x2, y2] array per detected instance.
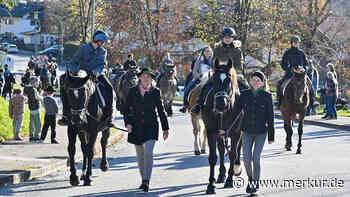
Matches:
[[124, 68, 169, 192]]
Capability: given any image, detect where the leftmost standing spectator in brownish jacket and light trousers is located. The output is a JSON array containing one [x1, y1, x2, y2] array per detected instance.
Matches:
[[9, 89, 25, 141]]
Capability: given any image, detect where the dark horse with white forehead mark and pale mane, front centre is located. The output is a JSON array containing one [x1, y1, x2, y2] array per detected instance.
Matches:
[[201, 59, 243, 194]]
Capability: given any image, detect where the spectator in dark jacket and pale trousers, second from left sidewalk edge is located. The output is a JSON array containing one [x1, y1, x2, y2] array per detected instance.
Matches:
[[24, 77, 42, 142]]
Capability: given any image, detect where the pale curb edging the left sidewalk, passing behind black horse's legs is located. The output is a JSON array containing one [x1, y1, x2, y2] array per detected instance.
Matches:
[[0, 131, 124, 187]]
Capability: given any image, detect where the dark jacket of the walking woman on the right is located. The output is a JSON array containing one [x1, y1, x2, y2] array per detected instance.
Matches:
[[234, 89, 275, 141]]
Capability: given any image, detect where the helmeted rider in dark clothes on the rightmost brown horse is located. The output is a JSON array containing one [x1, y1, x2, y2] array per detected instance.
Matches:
[[277, 35, 314, 107]]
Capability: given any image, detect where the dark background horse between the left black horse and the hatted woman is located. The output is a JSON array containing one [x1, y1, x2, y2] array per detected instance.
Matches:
[[112, 69, 138, 114]]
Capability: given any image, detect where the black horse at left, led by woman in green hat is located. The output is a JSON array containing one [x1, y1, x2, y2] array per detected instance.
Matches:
[[65, 72, 110, 186]]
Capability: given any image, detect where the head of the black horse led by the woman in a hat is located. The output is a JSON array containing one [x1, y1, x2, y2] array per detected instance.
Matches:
[[66, 71, 91, 127]]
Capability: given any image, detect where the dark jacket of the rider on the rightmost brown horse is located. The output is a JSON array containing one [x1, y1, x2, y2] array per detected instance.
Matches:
[[281, 47, 308, 72]]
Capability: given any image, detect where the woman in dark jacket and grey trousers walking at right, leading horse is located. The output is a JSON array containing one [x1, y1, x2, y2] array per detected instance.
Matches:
[[220, 71, 275, 194]]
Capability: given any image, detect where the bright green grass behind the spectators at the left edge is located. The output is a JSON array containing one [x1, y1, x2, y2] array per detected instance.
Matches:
[[0, 97, 44, 142]]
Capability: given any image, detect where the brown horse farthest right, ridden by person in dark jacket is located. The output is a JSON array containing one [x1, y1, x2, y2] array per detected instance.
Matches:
[[280, 66, 310, 154]]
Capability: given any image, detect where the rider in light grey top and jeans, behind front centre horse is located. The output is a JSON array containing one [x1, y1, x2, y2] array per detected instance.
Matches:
[[180, 46, 213, 113]]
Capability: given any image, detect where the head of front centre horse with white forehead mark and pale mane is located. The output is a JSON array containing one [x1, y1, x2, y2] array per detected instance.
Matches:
[[212, 59, 237, 114]]
